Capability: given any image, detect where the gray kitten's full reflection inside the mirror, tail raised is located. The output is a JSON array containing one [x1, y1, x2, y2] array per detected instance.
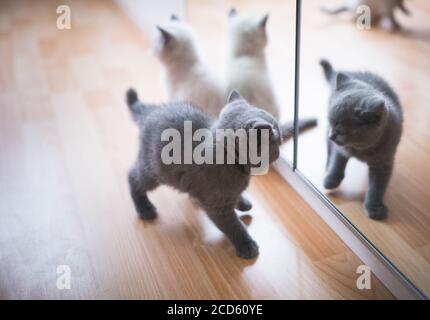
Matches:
[[321, 60, 403, 219]]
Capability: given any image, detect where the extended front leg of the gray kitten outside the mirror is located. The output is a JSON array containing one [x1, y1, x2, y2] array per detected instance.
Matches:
[[206, 206, 258, 259]]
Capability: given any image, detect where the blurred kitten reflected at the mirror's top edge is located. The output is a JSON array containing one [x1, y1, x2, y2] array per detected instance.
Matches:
[[321, 0, 410, 31]]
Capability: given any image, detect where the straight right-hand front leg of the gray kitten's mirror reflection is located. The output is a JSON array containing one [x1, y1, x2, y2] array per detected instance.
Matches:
[[364, 164, 393, 220]]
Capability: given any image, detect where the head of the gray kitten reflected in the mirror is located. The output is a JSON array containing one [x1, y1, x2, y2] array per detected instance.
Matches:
[[328, 90, 388, 150]]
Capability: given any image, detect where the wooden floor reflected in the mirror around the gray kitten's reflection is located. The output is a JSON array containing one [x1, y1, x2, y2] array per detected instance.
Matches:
[[298, 0, 430, 296]]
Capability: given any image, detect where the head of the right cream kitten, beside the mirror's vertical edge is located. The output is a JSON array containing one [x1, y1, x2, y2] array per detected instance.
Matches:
[[228, 9, 269, 53]]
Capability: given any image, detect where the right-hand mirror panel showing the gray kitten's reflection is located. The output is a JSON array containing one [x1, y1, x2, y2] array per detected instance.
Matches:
[[297, 0, 430, 296]]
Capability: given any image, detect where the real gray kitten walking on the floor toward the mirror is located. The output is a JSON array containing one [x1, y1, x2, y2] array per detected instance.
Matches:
[[127, 89, 282, 259]]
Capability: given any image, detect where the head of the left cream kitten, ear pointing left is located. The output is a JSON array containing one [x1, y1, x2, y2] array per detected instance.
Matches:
[[153, 19, 197, 63]]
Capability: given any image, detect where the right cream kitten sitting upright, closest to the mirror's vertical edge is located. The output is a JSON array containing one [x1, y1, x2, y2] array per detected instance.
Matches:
[[227, 9, 280, 120]]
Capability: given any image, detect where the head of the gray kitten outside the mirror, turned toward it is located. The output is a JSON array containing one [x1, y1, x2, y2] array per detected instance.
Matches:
[[219, 91, 282, 163]]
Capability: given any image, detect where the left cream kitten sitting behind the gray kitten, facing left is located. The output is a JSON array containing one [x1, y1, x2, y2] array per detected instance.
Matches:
[[154, 15, 227, 117]]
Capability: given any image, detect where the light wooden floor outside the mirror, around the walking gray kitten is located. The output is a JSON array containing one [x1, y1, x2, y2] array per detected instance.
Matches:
[[0, 0, 393, 299]]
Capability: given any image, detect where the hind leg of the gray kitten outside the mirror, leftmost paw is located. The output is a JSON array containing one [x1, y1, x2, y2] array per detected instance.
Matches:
[[128, 168, 158, 220]]
